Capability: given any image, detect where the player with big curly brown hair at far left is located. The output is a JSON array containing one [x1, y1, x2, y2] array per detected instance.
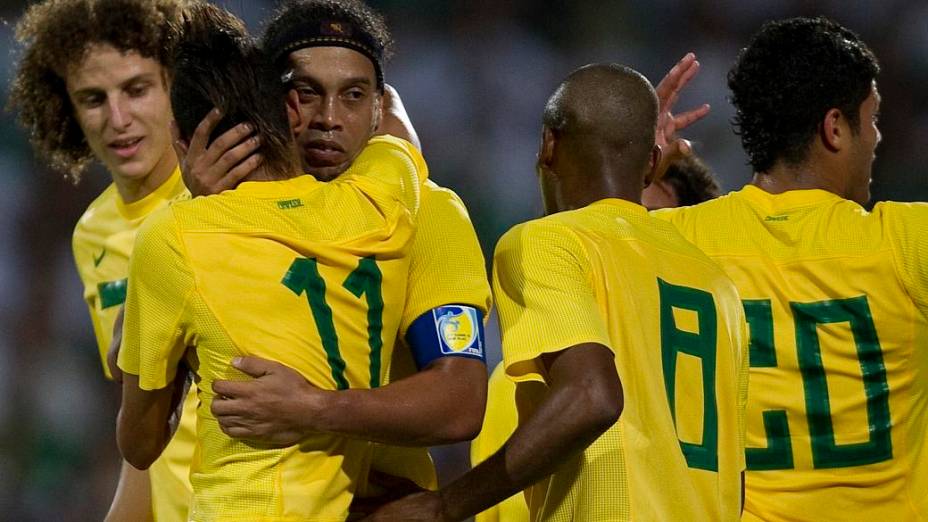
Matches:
[[11, 0, 196, 521]]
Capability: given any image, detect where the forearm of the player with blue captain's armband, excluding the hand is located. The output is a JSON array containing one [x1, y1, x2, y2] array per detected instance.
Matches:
[[318, 357, 487, 446]]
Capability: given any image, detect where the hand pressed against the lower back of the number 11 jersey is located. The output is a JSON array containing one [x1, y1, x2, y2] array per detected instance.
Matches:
[[211, 357, 324, 446]]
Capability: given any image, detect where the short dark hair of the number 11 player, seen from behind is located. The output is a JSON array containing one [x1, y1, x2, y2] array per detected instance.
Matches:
[[171, 3, 292, 177]]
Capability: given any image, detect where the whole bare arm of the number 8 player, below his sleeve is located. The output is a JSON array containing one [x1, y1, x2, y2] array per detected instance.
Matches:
[[366, 343, 624, 522]]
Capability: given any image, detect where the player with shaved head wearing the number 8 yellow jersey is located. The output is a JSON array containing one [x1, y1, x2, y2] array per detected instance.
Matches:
[[372, 65, 747, 520]]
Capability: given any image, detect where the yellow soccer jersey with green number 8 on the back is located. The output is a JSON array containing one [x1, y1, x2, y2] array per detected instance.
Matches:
[[493, 199, 747, 522]]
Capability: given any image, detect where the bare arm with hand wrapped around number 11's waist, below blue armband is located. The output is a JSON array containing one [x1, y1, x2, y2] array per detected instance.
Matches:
[[211, 350, 487, 446]]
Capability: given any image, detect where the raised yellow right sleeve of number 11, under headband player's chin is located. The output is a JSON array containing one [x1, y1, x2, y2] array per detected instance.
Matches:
[[340, 135, 429, 215]]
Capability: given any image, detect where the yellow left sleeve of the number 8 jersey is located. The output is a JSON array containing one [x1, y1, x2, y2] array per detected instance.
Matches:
[[493, 220, 613, 382]]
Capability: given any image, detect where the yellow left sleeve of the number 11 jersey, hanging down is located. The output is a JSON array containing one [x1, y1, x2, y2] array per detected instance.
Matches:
[[118, 207, 194, 390]]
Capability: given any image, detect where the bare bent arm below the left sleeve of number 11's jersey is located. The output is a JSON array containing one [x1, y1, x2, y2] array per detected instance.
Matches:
[[116, 372, 189, 469]]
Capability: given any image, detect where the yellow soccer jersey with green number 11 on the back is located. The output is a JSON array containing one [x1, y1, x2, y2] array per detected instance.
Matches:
[[119, 137, 426, 522]]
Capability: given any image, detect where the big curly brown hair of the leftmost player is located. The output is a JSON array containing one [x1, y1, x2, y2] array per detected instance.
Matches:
[[9, 0, 188, 183]]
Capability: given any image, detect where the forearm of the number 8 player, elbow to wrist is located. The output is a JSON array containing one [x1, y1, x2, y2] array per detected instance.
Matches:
[[439, 372, 620, 520]]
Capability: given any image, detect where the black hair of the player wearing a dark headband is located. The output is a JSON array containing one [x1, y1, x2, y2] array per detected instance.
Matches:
[[261, 0, 393, 92]]
